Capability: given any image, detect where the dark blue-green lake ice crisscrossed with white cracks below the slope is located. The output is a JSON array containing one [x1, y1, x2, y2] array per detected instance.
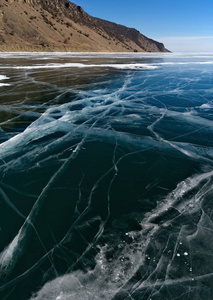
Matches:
[[0, 54, 213, 300]]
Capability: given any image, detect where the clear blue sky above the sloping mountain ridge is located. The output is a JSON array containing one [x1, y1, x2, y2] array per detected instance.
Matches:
[[74, 0, 213, 52]]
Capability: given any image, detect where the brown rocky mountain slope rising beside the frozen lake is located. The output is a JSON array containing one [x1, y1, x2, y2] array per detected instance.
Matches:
[[0, 0, 167, 52]]
